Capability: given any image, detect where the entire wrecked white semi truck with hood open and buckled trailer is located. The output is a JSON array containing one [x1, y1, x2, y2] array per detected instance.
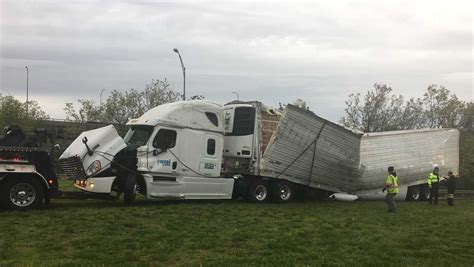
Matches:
[[60, 101, 459, 203]]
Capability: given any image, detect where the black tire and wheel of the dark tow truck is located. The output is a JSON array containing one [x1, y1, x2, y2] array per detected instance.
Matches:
[[0, 177, 44, 213]]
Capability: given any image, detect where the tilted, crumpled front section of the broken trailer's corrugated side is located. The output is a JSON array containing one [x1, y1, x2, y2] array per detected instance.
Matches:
[[260, 105, 361, 191]]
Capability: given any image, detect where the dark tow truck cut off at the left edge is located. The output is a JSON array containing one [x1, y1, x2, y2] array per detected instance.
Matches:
[[0, 125, 60, 210]]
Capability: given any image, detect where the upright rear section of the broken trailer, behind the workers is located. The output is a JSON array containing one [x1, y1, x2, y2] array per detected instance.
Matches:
[[360, 129, 459, 191]]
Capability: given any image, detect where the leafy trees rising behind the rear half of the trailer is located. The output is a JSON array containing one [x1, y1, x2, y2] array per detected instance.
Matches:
[[340, 83, 474, 132]]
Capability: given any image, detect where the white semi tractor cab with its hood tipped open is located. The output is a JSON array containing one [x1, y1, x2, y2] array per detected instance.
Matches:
[[60, 101, 234, 203]]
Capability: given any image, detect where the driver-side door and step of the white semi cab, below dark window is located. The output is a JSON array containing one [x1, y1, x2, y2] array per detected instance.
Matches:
[[148, 127, 184, 198]]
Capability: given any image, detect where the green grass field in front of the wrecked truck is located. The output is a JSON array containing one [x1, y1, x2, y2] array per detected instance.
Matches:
[[0, 183, 474, 266]]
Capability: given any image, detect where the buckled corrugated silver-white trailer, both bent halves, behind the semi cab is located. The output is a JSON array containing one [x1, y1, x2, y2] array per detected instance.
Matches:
[[243, 105, 459, 200]]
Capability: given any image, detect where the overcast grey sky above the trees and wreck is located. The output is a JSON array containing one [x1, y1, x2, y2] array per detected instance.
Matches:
[[0, 0, 474, 122]]
